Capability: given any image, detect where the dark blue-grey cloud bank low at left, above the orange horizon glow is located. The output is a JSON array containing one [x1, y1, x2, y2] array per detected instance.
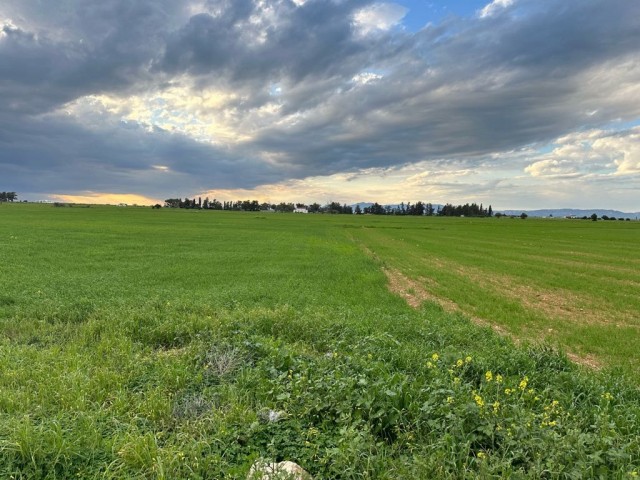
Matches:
[[0, 113, 279, 197]]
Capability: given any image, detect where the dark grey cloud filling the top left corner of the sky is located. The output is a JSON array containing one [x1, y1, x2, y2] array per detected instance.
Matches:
[[0, 0, 185, 113]]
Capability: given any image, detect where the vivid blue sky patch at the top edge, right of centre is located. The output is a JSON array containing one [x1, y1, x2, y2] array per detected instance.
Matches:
[[393, 0, 490, 32]]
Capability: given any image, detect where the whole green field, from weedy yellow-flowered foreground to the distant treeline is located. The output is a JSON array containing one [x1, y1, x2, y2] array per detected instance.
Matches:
[[0, 204, 640, 479]]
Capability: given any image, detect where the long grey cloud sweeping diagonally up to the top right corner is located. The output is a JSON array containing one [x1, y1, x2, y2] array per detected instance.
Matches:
[[251, 1, 640, 173]]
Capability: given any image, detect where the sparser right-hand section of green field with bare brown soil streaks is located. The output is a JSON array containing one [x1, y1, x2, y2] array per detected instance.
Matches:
[[354, 218, 640, 374]]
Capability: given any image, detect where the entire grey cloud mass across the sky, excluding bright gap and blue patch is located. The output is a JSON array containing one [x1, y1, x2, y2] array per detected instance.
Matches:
[[0, 0, 640, 196]]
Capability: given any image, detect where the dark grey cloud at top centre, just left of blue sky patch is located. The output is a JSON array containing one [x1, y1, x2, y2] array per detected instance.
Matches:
[[158, 0, 376, 83]]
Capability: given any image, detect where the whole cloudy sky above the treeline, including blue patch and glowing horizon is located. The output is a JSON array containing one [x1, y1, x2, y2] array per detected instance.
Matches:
[[0, 0, 640, 212]]
